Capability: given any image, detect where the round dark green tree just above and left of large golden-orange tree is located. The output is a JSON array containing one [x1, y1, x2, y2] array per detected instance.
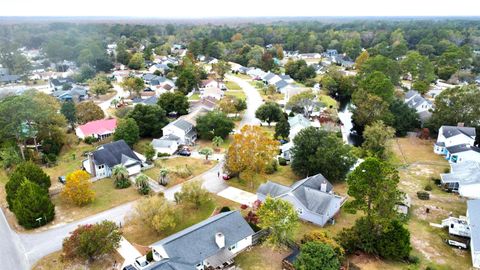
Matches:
[[196, 111, 235, 140]]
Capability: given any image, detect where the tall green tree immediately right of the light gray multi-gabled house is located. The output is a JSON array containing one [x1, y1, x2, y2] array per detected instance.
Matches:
[[347, 157, 402, 220]]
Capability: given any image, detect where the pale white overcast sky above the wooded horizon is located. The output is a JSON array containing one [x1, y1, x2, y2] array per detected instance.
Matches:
[[0, 0, 480, 18]]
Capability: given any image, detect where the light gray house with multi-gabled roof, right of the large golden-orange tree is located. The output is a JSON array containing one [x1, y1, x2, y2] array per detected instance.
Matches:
[[257, 174, 345, 226]]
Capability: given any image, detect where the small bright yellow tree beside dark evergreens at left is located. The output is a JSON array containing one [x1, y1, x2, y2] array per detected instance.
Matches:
[[62, 170, 95, 206]]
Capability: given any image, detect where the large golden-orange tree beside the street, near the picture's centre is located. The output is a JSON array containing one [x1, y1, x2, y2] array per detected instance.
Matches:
[[225, 126, 279, 188]]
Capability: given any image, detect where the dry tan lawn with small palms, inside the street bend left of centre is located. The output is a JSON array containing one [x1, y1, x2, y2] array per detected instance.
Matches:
[[144, 156, 217, 187]]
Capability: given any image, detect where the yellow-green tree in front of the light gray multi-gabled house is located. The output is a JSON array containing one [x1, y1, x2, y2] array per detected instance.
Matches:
[[257, 197, 299, 246]]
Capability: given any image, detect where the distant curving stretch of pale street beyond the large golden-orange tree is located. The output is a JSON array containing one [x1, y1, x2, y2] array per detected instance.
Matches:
[[225, 75, 263, 129]]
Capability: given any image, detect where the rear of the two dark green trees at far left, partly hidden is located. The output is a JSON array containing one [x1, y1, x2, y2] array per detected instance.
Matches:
[[5, 161, 51, 209]]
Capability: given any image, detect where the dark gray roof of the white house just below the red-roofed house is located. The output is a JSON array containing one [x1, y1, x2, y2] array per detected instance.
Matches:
[[93, 140, 141, 168]]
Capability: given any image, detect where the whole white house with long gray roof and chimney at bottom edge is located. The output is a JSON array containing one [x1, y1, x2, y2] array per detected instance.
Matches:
[[149, 211, 254, 270]]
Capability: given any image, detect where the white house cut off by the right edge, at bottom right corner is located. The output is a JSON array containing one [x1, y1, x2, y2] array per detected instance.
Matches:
[[467, 200, 480, 268]]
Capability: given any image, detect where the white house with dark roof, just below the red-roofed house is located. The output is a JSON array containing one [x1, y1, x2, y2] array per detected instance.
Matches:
[[82, 140, 143, 178]]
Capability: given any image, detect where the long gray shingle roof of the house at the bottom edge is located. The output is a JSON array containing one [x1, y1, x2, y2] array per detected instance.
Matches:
[[152, 211, 254, 270]]
